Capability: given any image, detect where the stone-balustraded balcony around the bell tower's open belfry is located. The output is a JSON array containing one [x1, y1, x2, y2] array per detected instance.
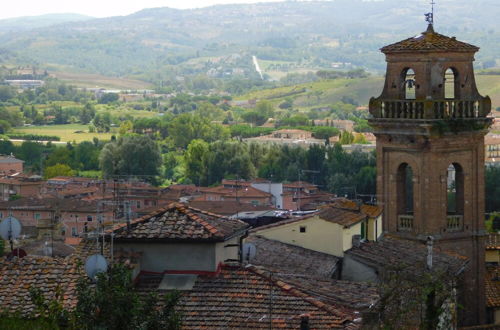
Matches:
[[370, 98, 491, 119]]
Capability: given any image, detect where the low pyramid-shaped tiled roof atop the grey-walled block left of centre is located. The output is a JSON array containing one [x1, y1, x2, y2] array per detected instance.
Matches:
[[108, 203, 248, 241]]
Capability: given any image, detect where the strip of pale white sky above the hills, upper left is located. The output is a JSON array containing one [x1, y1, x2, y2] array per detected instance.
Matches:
[[0, 0, 286, 19]]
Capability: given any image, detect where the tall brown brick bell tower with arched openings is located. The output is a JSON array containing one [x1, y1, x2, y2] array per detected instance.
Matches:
[[370, 22, 491, 325]]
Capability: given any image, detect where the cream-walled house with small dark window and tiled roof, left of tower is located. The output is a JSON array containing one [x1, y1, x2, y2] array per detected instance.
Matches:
[[254, 199, 382, 257]]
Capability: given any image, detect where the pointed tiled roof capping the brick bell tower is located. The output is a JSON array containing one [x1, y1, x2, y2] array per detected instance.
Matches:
[[380, 24, 479, 54]]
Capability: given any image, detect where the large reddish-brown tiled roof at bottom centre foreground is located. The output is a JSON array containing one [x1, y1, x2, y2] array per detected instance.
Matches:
[[139, 266, 353, 329]]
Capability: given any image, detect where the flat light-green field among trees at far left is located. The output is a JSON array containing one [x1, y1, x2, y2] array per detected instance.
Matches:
[[14, 124, 113, 143]]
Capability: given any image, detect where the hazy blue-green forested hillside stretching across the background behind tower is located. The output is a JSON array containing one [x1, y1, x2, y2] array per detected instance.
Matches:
[[0, 0, 500, 81]]
